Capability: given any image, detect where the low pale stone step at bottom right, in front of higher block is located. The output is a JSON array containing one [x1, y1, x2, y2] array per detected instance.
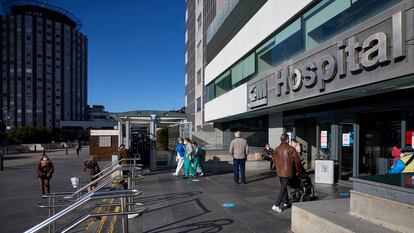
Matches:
[[291, 198, 396, 233]]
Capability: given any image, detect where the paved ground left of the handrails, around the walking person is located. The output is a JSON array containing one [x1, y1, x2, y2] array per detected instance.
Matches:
[[0, 148, 94, 233]]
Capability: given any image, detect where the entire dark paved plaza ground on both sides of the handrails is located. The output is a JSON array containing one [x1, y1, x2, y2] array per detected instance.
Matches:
[[0, 148, 348, 233]]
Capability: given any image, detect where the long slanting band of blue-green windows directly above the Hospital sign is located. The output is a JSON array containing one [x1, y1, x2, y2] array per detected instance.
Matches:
[[206, 0, 402, 102]]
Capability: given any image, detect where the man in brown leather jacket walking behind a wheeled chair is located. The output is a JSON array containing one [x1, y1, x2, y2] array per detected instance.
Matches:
[[272, 134, 301, 213]]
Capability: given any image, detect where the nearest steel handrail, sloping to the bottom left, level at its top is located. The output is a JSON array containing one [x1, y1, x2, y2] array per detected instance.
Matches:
[[25, 189, 141, 233]]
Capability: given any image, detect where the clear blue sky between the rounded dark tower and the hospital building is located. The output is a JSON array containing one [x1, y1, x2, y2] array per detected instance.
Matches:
[[44, 0, 185, 112]]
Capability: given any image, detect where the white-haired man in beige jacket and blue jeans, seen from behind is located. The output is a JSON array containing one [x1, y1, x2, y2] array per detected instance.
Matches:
[[229, 131, 249, 184]]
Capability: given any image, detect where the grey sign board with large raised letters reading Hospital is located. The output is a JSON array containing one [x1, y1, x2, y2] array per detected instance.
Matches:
[[247, 9, 414, 111]]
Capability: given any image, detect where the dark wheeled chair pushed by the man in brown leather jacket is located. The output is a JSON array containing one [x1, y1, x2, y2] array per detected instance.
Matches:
[[288, 160, 318, 202]]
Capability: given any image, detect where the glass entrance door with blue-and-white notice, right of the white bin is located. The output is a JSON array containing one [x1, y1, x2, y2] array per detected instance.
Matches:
[[339, 124, 355, 180]]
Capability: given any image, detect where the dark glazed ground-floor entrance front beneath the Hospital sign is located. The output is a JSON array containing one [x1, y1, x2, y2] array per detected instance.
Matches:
[[283, 88, 414, 181]]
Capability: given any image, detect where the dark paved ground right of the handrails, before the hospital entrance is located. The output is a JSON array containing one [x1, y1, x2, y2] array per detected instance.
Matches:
[[138, 171, 349, 233]]
